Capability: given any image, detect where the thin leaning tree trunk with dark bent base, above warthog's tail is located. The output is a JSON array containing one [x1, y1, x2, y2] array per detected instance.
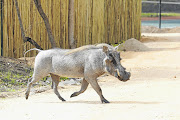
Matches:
[[14, 0, 43, 50]]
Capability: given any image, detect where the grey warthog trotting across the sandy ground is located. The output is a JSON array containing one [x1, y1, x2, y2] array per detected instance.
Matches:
[[25, 46, 130, 103]]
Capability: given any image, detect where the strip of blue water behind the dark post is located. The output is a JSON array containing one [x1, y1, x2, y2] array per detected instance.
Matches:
[[141, 19, 180, 28]]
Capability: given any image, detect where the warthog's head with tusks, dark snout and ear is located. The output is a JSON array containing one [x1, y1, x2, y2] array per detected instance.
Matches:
[[103, 46, 131, 82]]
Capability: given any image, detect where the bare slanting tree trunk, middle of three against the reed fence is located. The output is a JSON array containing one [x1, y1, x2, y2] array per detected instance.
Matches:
[[34, 0, 56, 48]]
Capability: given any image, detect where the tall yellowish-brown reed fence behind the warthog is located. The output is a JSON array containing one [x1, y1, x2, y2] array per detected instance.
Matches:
[[0, 0, 141, 58]]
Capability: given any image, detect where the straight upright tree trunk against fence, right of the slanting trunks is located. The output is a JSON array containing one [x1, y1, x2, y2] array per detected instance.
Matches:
[[68, 0, 76, 49]]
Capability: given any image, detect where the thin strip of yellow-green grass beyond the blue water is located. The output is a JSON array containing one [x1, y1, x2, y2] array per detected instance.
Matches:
[[141, 13, 180, 17]]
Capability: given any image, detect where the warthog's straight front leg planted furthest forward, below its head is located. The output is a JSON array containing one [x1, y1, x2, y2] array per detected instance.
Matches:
[[88, 79, 110, 103]]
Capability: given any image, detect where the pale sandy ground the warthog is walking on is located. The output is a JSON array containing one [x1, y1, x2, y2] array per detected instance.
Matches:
[[0, 34, 180, 120]]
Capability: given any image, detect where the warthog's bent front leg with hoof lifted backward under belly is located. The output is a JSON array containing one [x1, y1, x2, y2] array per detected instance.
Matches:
[[71, 78, 89, 97]]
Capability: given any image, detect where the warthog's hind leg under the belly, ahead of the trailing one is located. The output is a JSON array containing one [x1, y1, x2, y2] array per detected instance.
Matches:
[[51, 74, 66, 101]]
